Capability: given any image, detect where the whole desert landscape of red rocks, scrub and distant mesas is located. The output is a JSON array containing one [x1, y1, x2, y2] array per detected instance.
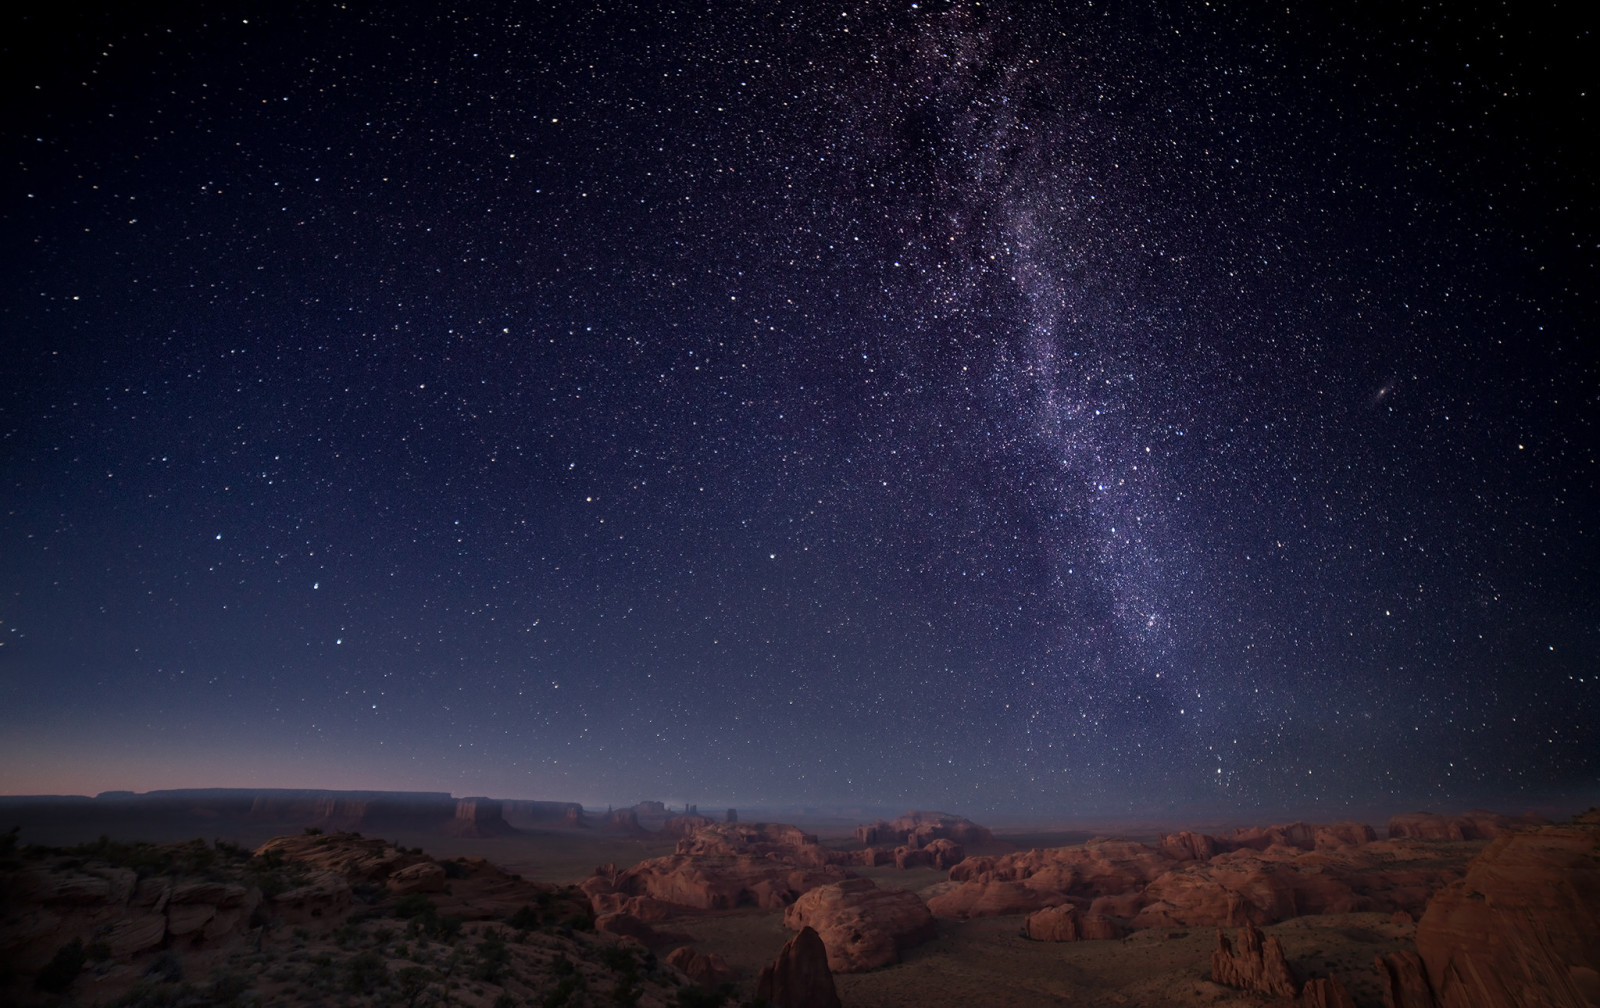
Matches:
[[0, 792, 1600, 1008]]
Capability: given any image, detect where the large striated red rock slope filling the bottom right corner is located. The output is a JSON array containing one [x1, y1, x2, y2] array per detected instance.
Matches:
[[1416, 813, 1600, 1008]]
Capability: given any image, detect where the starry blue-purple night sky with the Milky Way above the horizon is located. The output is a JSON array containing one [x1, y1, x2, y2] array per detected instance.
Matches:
[[0, 0, 1600, 818]]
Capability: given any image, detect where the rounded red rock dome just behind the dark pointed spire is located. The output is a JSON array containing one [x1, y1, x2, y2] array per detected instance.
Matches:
[[784, 878, 939, 973]]
